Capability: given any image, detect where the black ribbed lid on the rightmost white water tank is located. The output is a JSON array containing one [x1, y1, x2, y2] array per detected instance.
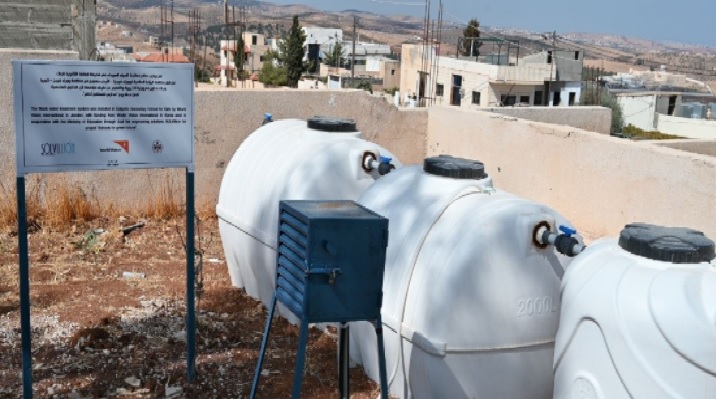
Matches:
[[619, 223, 714, 263]]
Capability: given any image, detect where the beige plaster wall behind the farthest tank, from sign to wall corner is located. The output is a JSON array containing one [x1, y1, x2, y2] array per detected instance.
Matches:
[[195, 90, 428, 205]]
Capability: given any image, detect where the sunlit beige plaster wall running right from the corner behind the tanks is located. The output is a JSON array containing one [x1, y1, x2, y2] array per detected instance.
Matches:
[[428, 108, 716, 242]]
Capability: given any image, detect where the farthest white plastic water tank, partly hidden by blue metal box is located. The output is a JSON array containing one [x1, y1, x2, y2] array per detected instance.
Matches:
[[216, 117, 400, 316]]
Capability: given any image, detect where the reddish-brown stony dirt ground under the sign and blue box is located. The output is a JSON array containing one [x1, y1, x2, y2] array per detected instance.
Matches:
[[0, 218, 378, 398]]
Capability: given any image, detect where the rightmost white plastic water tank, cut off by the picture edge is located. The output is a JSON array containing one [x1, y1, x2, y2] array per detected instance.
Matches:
[[554, 224, 716, 399]]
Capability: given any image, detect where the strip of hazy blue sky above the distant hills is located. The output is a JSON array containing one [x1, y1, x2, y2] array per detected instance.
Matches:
[[268, 0, 716, 47]]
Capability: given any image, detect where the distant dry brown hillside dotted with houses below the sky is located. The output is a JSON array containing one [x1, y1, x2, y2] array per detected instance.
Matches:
[[97, 0, 716, 81]]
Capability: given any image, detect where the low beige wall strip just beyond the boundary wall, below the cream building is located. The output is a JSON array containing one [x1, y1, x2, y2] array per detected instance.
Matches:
[[485, 107, 612, 134]]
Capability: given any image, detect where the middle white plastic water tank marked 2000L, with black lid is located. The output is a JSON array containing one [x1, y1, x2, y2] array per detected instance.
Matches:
[[350, 156, 570, 399]]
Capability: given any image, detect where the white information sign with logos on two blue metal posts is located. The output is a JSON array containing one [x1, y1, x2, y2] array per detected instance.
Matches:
[[13, 61, 196, 399]]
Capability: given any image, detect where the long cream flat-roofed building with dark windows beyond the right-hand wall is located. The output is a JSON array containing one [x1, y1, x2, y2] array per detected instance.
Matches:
[[400, 44, 581, 108]]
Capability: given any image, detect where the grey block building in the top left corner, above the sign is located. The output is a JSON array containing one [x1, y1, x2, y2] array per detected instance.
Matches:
[[0, 0, 97, 60]]
